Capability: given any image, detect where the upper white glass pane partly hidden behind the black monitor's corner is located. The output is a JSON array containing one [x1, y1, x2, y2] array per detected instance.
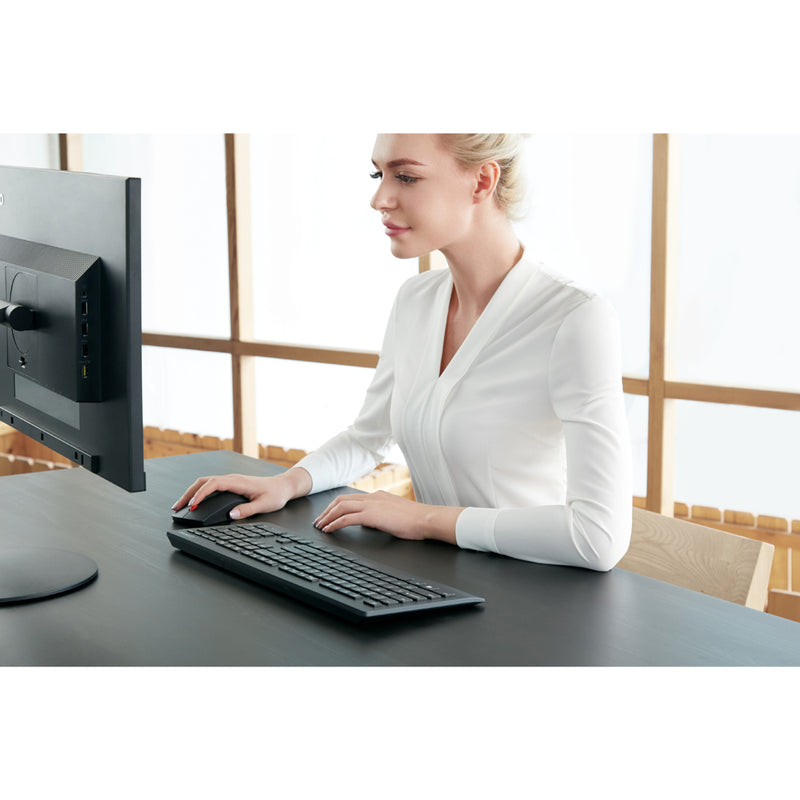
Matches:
[[83, 134, 230, 337]]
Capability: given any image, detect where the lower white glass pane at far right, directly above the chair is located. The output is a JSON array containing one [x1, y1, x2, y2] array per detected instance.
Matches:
[[675, 401, 800, 519]]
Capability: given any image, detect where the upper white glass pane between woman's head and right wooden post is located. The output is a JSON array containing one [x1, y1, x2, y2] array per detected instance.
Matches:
[[517, 134, 653, 377]]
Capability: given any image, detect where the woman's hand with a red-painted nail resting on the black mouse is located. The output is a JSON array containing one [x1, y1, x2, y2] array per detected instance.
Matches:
[[172, 467, 311, 519]]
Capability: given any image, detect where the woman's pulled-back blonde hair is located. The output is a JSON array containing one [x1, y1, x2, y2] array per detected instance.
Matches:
[[441, 133, 527, 220]]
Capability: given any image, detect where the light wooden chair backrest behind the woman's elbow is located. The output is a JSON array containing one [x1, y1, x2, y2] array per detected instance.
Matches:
[[617, 508, 775, 611]]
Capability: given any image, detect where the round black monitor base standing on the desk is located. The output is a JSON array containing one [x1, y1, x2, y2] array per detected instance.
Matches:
[[0, 547, 97, 605]]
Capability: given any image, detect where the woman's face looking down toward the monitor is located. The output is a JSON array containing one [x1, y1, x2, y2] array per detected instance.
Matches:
[[370, 133, 476, 258]]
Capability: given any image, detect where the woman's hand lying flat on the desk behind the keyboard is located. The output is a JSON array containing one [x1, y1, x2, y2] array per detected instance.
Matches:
[[314, 492, 461, 544]]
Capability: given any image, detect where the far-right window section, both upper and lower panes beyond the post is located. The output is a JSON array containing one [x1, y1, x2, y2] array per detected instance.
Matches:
[[673, 135, 800, 518]]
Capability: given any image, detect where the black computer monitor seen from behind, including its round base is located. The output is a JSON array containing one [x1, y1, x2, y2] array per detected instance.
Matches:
[[0, 166, 145, 603]]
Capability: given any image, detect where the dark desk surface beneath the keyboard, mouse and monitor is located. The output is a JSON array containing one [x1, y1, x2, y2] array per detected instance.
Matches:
[[0, 452, 800, 666]]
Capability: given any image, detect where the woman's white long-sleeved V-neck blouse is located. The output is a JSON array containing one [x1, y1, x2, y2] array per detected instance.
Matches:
[[298, 258, 632, 570]]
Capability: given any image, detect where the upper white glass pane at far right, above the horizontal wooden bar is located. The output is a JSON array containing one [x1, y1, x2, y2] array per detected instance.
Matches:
[[675, 135, 800, 391]]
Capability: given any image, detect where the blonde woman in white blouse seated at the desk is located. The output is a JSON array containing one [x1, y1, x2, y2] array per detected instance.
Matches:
[[174, 134, 631, 570]]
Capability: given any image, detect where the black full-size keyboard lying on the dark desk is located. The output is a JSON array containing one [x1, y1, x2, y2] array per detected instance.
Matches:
[[167, 522, 484, 621]]
